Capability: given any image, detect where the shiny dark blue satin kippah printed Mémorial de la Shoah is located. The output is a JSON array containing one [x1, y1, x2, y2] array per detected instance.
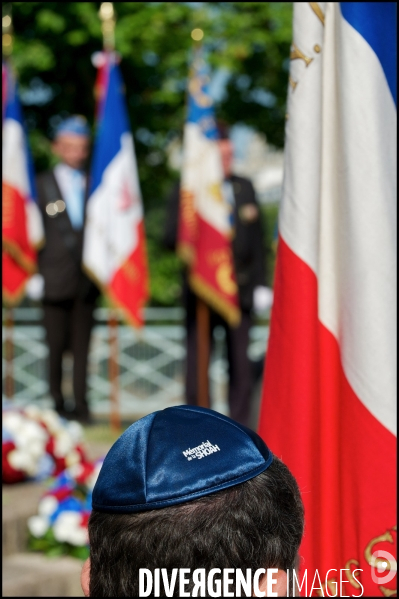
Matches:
[[93, 406, 273, 513]]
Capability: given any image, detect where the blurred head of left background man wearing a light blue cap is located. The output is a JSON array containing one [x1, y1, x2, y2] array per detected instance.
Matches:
[[52, 115, 90, 170]]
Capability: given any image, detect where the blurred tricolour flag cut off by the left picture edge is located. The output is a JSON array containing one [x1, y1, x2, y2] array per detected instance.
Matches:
[[2, 64, 44, 305]]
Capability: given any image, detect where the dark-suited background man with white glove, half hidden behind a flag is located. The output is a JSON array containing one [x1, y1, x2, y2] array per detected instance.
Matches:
[[164, 123, 268, 426]]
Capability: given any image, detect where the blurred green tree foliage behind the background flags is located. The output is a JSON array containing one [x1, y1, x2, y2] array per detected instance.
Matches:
[[7, 2, 292, 305]]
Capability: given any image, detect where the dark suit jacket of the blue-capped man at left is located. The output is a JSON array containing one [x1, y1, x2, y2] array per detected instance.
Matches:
[[37, 171, 99, 302]]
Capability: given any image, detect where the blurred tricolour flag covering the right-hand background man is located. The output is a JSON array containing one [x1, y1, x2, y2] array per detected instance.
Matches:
[[177, 51, 240, 325]]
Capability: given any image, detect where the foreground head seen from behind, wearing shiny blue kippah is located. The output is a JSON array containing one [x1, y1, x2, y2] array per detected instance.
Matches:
[[82, 406, 303, 597]]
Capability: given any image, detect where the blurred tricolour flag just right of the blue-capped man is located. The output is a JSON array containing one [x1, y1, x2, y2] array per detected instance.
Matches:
[[83, 55, 148, 326]]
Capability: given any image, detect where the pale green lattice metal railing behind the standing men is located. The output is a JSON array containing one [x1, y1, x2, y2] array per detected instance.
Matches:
[[3, 308, 269, 418]]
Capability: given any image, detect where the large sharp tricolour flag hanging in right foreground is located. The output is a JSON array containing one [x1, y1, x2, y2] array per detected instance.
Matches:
[[259, 2, 396, 596]]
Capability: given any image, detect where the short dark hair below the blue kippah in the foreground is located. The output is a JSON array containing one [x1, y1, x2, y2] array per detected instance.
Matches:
[[89, 458, 303, 597]]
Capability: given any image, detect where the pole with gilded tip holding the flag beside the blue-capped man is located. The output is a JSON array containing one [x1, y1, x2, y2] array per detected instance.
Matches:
[[99, 2, 121, 433]]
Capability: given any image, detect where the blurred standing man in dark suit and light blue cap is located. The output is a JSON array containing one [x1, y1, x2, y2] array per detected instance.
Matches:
[[37, 116, 99, 423]]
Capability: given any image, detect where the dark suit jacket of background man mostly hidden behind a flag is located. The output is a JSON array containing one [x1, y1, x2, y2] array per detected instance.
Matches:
[[164, 175, 266, 310]]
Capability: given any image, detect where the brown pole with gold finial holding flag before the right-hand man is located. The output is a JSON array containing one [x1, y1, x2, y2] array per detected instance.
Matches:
[[191, 28, 211, 408]]
